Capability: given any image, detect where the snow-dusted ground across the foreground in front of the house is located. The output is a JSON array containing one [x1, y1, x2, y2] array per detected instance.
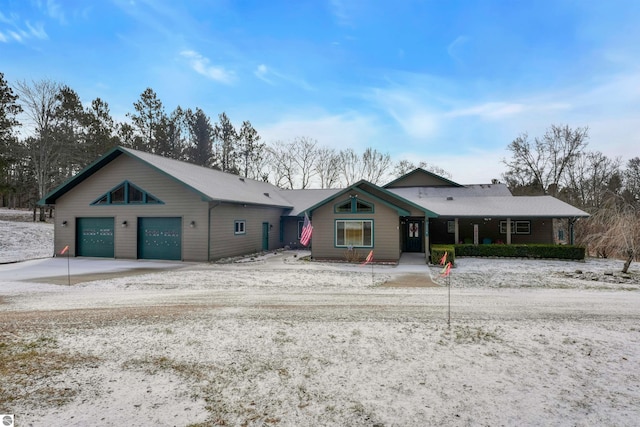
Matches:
[[0, 209, 640, 426]]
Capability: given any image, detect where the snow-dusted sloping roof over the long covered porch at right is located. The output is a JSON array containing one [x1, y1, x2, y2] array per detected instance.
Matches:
[[389, 184, 589, 218]]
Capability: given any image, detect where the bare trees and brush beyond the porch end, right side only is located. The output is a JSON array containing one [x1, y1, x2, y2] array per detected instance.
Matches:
[[503, 125, 640, 273]]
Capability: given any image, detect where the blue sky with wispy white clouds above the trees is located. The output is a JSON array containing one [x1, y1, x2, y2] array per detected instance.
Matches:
[[0, 0, 640, 184]]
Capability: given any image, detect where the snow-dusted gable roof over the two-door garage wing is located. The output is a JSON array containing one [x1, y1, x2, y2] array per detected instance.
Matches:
[[38, 147, 293, 209]]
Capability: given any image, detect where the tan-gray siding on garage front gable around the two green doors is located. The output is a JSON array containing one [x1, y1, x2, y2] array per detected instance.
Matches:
[[55, 156, 208, 261]]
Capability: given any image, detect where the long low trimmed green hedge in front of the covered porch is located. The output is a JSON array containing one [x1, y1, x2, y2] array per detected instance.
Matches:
[[453, 244, 585, 260]]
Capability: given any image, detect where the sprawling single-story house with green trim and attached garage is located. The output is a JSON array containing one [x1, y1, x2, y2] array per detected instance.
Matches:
[[38, 147, 588, 262]]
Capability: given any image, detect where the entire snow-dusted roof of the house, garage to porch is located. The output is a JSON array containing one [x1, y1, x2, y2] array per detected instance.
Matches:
[[38, 147, 589, 218]]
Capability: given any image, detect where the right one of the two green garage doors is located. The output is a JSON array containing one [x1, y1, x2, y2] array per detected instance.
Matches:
[[138, 218, 182, 261]]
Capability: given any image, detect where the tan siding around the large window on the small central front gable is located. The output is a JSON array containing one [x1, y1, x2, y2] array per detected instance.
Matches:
[[311, 196, 400, 261]]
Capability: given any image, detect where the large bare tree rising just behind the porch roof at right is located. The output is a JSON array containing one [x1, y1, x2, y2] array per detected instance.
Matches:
[[503, 125, 588, 196]]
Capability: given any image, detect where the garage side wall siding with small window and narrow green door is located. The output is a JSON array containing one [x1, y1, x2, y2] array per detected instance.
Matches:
[[210, 203, 282, 260]]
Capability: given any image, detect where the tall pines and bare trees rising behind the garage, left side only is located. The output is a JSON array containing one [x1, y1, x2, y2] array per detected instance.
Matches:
[[0, 73, 450, 214]]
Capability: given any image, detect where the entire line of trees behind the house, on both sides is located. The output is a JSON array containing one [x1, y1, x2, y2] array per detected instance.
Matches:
[[0, 73, 640, 270]]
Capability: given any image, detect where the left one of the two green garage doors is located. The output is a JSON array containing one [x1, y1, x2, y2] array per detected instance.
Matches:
[[76, 218, 114, 258]]
